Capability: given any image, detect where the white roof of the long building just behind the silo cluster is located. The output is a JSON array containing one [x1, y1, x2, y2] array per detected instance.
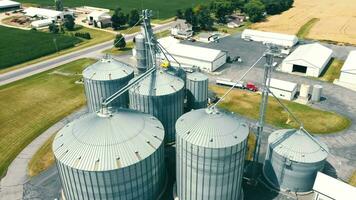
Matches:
[[158, 37, 224, 62]]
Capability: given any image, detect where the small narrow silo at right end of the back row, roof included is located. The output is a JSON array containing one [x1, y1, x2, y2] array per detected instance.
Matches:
[[186, 72, 209, 110]]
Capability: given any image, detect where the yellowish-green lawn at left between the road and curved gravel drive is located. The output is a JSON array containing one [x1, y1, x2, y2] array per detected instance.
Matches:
[[0, 59, 95, 176]]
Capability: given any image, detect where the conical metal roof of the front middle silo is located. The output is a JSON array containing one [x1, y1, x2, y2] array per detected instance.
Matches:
[[176, 108, 249, 148]]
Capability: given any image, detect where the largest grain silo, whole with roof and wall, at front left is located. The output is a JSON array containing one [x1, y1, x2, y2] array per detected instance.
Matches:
[[53, 109, 165, 200]]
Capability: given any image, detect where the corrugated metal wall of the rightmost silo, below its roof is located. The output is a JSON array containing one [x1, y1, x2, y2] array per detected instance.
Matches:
[[263, 148, 325, 192]]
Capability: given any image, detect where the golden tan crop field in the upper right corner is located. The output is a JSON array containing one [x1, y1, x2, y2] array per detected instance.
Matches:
[[252, 0, 356, 45]]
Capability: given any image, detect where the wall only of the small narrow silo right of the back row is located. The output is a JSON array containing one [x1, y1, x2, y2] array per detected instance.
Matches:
[[186, 79, 208, 110]]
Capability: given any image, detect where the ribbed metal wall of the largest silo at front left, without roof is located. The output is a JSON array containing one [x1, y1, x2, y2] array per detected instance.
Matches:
[[56, 143, 166, 200]]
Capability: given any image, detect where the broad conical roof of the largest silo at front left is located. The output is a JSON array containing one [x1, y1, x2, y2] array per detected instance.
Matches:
[[53, 109, 164, 171]]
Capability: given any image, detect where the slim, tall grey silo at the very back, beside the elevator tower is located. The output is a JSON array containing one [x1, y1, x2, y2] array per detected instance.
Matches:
[[135, 34, 147, 72]]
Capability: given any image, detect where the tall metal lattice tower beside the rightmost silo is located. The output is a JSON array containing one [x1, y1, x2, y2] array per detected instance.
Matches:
[[252, 45, 277, 181]]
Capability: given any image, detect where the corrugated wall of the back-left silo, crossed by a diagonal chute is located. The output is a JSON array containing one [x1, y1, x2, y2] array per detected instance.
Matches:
[[84, 73, 134, 112]]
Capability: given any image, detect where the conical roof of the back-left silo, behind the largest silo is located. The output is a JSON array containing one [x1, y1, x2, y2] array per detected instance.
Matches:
[[83, 58, 134, 81]]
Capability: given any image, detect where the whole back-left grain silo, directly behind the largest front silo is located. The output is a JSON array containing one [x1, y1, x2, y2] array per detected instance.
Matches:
[[83, 58, 134, 112]]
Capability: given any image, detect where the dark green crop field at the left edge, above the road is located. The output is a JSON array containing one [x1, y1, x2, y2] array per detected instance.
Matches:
[[0, 26, 81, 69]]
